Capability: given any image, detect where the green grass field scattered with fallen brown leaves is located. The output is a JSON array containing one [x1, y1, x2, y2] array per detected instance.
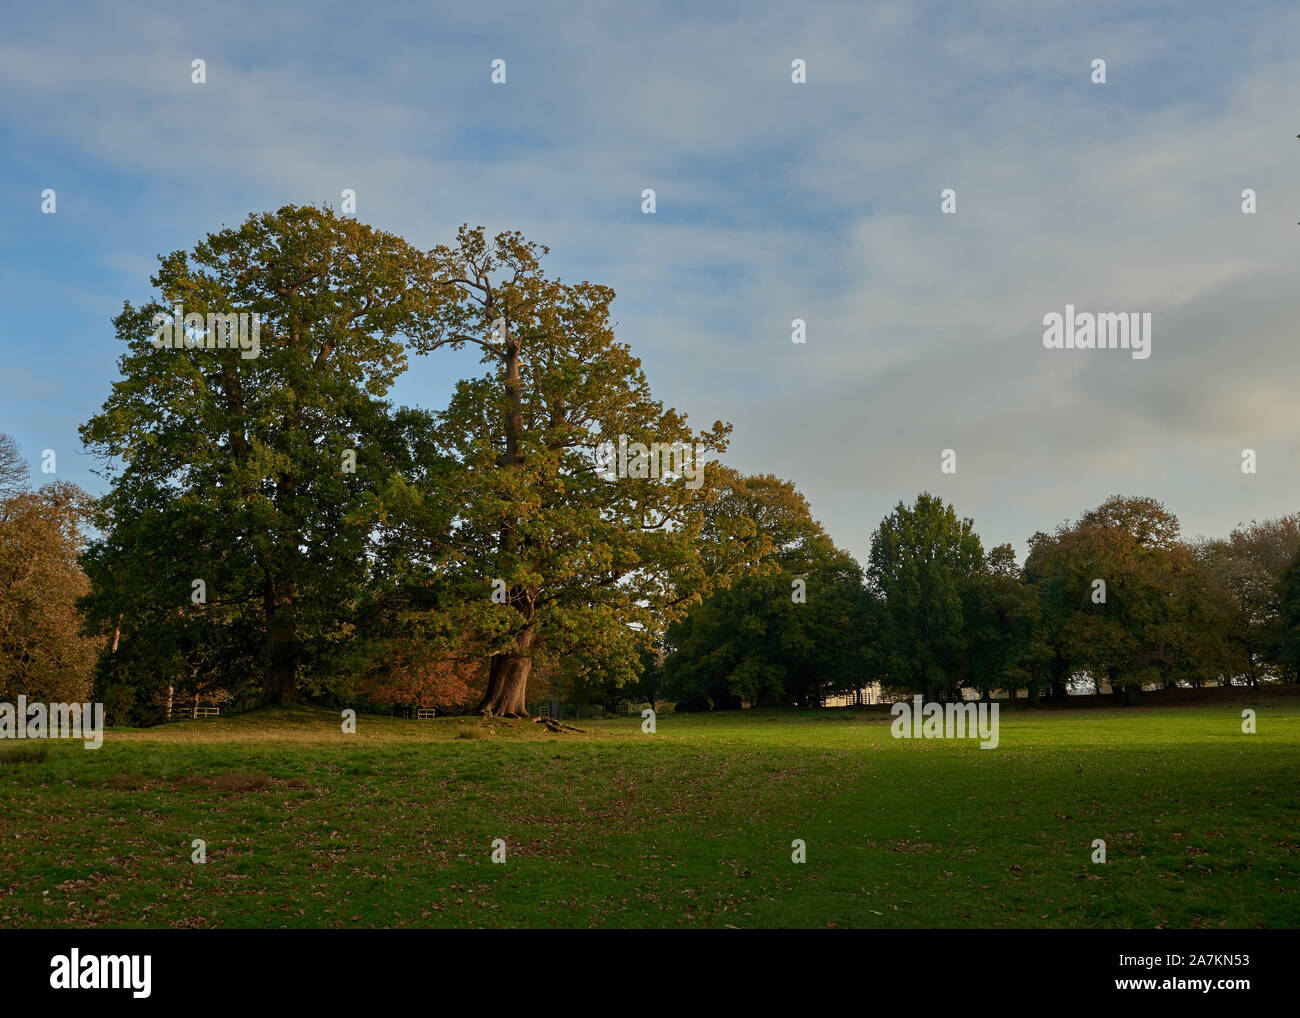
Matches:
[[0, 690, 1300, 928]]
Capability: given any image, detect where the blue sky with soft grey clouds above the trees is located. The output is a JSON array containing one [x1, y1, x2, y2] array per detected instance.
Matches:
[[0, 0, 1300, 559]]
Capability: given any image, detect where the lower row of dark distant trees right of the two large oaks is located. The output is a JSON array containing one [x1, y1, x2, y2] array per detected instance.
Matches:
[[654, 493, 1300, 709]]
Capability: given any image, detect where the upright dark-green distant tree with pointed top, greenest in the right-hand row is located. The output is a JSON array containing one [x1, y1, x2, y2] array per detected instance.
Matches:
[[867, 493, 984, 701]]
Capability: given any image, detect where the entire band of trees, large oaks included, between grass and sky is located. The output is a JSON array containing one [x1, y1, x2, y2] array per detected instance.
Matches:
[[0, 205, 1300, 723]]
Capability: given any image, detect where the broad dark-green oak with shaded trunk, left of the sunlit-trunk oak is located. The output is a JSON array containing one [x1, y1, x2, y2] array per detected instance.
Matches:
[[82, 205, 437, 703]]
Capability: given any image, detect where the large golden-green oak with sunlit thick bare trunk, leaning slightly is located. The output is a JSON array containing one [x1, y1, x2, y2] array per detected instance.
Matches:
[[419, 228, 762, 715]]
